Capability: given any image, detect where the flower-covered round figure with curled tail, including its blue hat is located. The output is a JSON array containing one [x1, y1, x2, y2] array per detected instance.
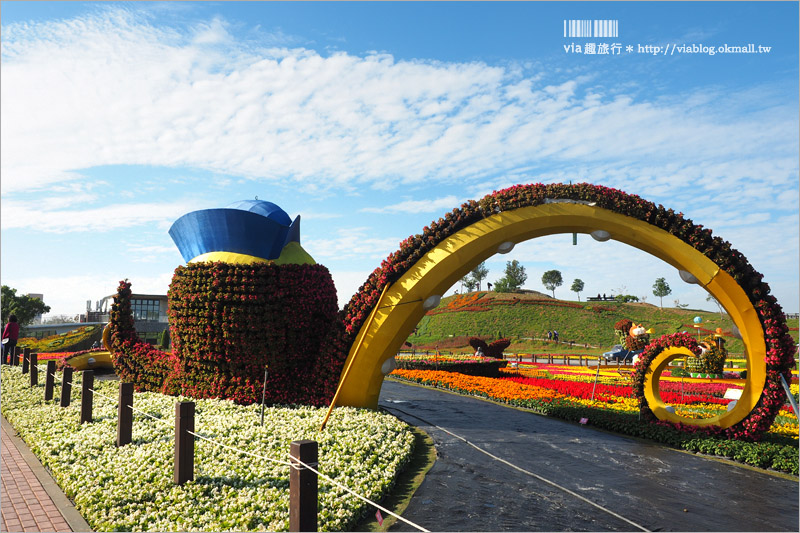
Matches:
[[112, 200, 347, 405]]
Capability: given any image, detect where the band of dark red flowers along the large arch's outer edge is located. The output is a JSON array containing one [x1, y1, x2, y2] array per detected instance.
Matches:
[[344, 183, 795, 439]]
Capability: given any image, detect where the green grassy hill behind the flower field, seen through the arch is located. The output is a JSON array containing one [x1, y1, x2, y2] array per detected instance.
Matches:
[[408, 291, 798, 354]]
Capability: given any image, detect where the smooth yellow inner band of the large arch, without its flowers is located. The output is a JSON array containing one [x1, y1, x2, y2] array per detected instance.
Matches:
[[336, 201, 766, 427]]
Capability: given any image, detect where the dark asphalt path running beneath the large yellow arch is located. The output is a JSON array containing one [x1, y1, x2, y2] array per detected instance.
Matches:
[[379, 380, 800, 531]]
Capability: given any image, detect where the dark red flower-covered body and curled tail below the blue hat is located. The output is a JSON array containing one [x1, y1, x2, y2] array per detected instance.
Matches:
[[111, 263, 348, 405]]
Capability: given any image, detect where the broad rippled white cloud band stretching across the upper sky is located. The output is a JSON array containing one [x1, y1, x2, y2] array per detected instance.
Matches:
[[2, 6, 797, 202]]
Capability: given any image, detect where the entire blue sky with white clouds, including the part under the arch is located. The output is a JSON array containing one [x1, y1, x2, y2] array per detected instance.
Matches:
[[0, 1, 800, 316]]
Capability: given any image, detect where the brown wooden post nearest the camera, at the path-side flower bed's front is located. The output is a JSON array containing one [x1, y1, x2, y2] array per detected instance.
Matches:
[[289, 440, 318, 531]]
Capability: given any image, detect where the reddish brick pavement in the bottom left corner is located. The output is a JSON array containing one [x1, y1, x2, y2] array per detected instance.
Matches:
[[0, 418, 91, 532]]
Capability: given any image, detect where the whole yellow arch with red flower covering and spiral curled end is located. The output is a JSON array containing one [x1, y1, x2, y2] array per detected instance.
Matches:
[[337, 183, 794, 438]]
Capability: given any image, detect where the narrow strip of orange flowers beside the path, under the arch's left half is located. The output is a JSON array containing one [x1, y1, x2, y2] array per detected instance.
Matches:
[[392, 369, 566, 402]]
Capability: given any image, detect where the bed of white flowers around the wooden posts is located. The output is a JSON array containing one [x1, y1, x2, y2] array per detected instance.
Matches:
[[2, 366, 414, 531]]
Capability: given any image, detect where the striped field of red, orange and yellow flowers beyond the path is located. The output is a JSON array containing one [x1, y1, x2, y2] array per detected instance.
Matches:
[[391, 364, 798, 474]]
